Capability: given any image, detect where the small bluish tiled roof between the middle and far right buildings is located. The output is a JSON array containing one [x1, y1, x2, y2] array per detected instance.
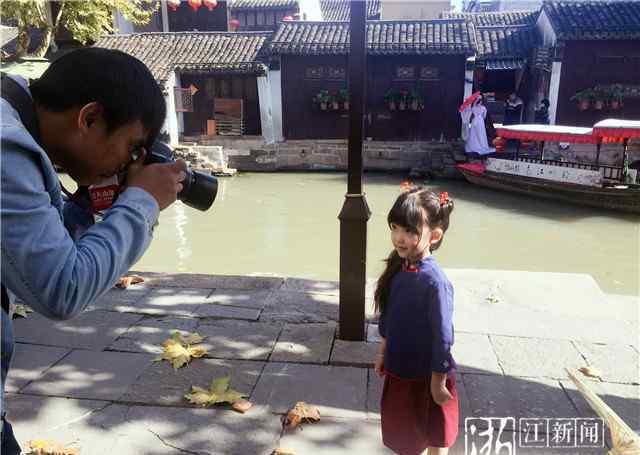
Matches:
[[476, 25, 540, 60]]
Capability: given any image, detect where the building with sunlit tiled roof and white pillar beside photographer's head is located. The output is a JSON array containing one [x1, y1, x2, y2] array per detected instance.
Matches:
[[96, 32, 270, 144]]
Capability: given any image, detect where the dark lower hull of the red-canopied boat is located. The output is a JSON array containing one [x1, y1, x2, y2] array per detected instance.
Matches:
[[460, 169, 640, 215]]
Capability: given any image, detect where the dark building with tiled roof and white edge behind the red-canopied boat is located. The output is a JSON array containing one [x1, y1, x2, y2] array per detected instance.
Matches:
[[537, 0, 640, 126]]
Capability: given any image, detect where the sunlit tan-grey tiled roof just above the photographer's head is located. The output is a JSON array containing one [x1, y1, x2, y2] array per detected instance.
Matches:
[[95, 32, 270, 83]]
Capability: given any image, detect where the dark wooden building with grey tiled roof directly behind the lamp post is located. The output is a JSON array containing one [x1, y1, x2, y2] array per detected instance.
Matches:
[[270, 20, 475, 140]]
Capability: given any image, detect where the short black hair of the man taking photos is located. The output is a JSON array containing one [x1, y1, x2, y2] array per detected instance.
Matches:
[[30, 47, 167, 144]]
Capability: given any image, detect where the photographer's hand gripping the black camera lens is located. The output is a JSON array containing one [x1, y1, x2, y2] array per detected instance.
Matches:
[[127, 154, 187, 210]]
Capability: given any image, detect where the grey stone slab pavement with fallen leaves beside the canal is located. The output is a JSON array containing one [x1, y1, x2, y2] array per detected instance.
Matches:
[[6, 269, 640, 455]]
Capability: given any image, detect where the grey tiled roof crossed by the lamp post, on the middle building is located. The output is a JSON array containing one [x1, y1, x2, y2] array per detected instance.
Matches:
[[271, 20, 475, 55]]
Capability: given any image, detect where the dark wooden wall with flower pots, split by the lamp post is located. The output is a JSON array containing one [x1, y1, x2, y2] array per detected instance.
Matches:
[[281, 55, 465, 140]]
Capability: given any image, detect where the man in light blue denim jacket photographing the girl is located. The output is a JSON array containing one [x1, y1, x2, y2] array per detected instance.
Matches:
[[0, 48, 186, 455]]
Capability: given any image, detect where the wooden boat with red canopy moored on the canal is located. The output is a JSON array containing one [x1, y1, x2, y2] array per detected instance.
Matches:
[[458, 119, 640, 214]]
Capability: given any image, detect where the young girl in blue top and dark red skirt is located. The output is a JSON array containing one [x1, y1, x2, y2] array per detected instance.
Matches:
[[375, 188, 458, 455]]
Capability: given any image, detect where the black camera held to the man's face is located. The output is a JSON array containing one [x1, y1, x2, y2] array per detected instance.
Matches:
[[149, 141, 218, 211]]
